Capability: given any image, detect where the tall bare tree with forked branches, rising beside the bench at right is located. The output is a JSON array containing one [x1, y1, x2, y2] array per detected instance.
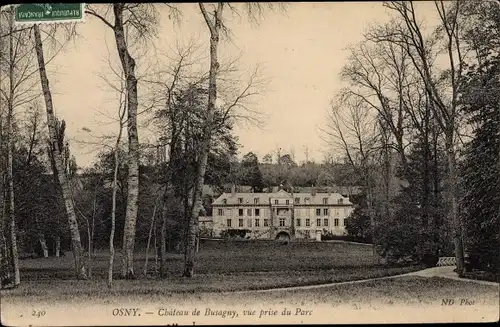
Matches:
[[369, 1, 465, 276]]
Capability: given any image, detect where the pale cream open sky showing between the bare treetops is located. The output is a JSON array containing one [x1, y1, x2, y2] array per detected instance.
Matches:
[[48, 2, 438, 166]]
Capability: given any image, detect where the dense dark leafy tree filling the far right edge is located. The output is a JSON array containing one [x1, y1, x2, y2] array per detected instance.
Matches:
[[460, 1, 500, 280]]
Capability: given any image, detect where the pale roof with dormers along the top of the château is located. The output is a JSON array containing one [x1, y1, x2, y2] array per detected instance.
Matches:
[[213, 190, 352, 205]]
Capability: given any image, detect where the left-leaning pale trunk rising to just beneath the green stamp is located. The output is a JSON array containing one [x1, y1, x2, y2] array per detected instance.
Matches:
[[34, 24, 87, 279]]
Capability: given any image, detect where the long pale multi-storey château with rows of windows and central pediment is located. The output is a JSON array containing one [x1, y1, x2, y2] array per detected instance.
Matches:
[[211, 188, 353, 239]]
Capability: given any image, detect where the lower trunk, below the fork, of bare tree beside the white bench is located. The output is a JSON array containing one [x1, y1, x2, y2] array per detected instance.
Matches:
[[445, 130, 465, 276]]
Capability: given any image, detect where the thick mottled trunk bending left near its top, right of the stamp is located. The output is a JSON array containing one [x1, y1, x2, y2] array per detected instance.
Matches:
[[113, 3, 139, 278]]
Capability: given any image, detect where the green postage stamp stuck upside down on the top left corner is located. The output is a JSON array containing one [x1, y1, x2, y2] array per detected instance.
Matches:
[[14, 3, 85, 24]]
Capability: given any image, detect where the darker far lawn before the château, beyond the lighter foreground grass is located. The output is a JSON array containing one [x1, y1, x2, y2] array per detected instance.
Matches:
[[21, 241, 377, 280]]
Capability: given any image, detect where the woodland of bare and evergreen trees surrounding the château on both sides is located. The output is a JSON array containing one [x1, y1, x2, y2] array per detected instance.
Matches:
[[0, 0, 500, 287]]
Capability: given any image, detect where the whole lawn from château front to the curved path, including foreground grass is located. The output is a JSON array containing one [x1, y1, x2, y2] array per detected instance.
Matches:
[[2, 242, 428, 301]]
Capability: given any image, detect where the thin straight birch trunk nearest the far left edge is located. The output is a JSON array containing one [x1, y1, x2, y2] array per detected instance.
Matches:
[[7, 14, 21, 286]]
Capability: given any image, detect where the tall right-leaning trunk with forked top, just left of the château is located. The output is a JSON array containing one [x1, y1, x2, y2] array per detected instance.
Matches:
[[183, 2, 223, 277]]
